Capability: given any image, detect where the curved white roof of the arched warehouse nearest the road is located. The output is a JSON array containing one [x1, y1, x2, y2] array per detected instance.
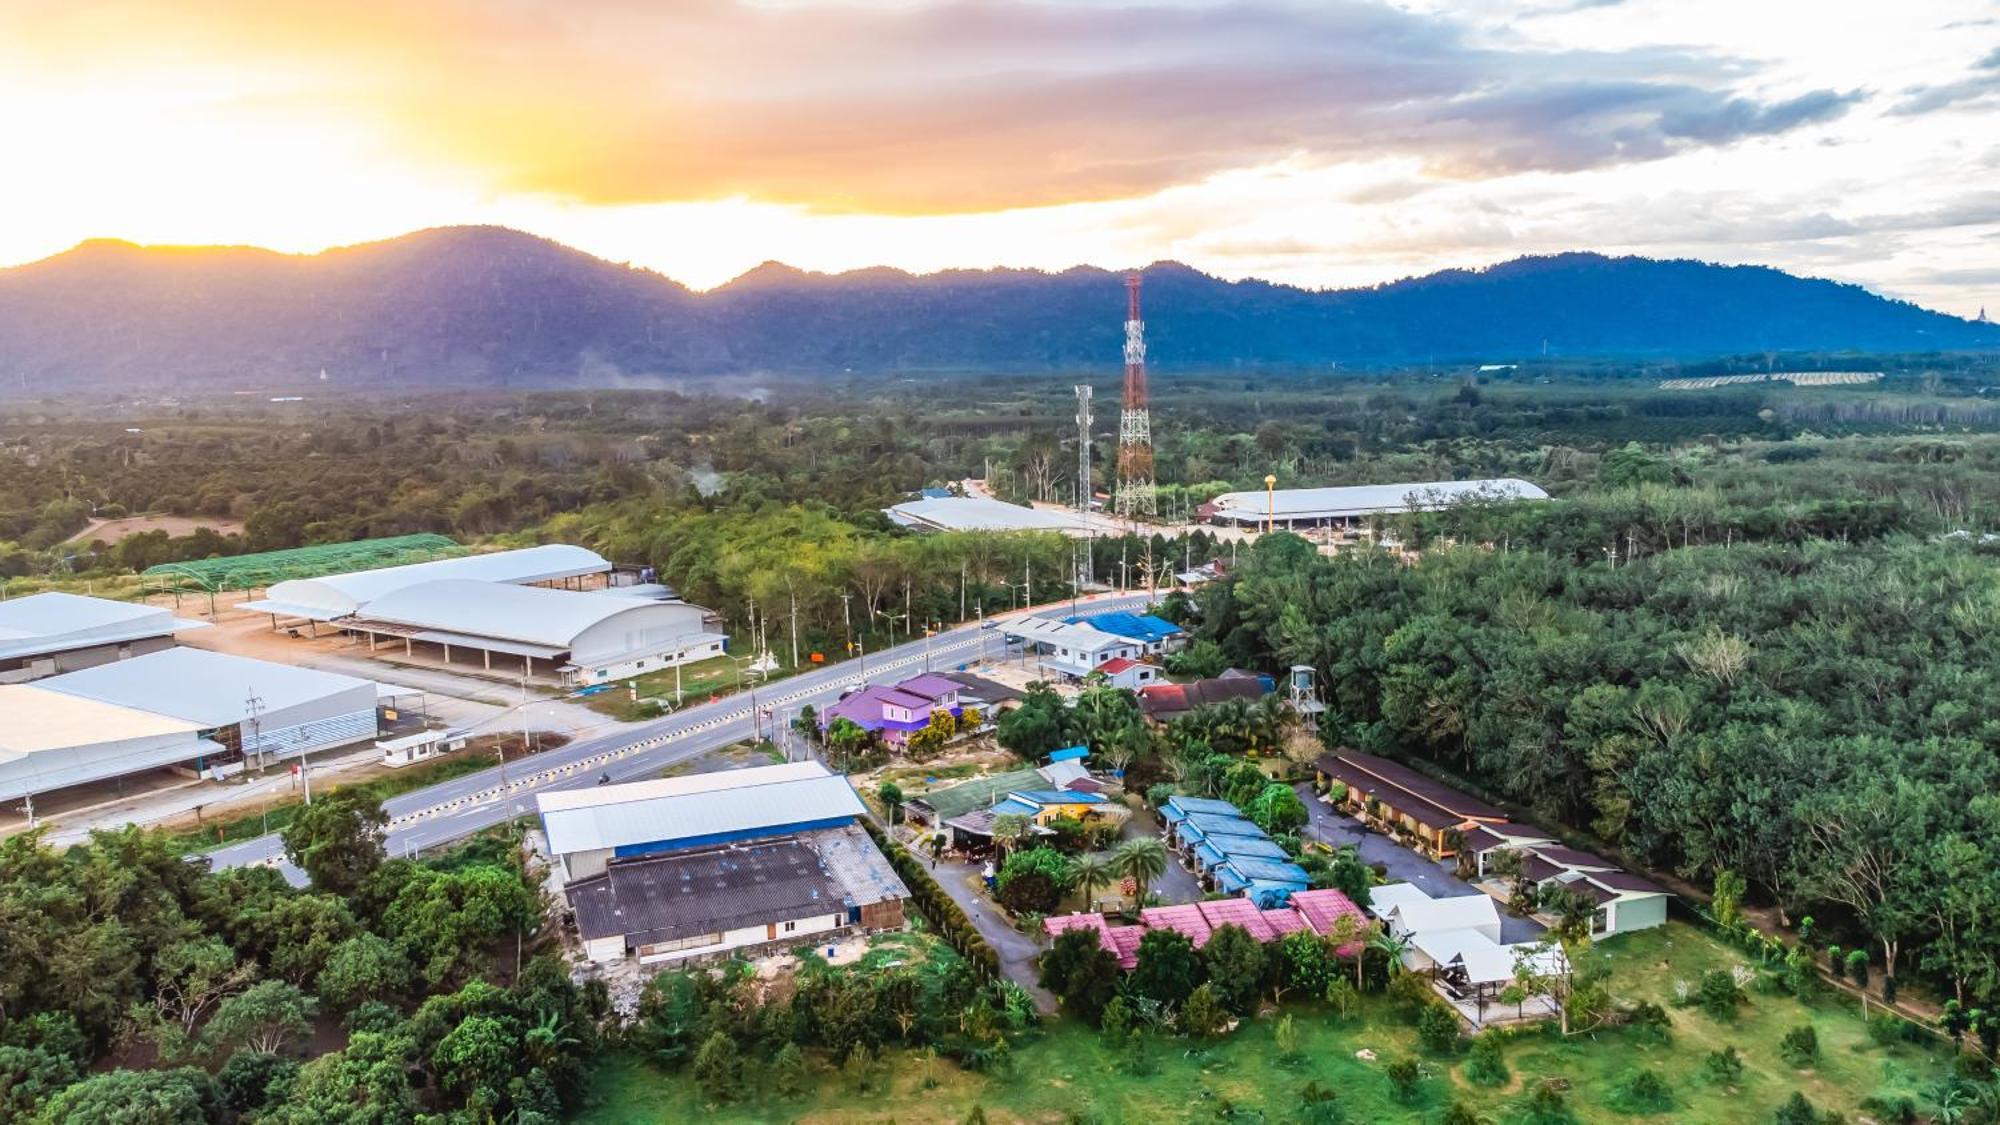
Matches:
[[350, 579, 702, 649]]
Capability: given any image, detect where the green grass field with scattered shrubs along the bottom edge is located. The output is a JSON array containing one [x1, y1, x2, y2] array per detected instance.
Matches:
[[580, 923, 1948, 1125]]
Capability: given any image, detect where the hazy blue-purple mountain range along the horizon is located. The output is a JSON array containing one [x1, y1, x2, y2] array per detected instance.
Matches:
[[0, 226, 2000, 390]]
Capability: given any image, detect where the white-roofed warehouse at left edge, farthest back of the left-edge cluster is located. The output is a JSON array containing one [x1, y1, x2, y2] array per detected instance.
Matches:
[[0, 593, 208, 683]]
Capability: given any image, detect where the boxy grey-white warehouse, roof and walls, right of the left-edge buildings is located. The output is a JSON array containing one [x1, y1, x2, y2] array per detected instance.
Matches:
[[38, 649, 382, 760]]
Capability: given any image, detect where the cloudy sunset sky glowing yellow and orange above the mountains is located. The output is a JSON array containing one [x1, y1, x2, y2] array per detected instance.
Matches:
[[0, 0, 2000, 316]]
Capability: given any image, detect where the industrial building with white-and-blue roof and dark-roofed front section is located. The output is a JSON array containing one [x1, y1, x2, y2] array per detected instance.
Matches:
[[536, 763, 908, 963]]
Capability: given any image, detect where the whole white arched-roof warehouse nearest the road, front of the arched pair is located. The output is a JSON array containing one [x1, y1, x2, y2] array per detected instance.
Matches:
[[338, 579, 728, 687]]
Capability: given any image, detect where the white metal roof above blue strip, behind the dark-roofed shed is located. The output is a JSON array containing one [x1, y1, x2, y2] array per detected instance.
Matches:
[[536, 763, 868, 855]]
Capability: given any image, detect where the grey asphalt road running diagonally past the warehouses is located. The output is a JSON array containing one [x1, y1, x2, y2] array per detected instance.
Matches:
[[206, 595, 1148, 885]]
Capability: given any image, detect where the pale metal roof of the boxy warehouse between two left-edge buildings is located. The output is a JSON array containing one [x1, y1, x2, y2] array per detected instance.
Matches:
[[38, 649, 376, 727]]
